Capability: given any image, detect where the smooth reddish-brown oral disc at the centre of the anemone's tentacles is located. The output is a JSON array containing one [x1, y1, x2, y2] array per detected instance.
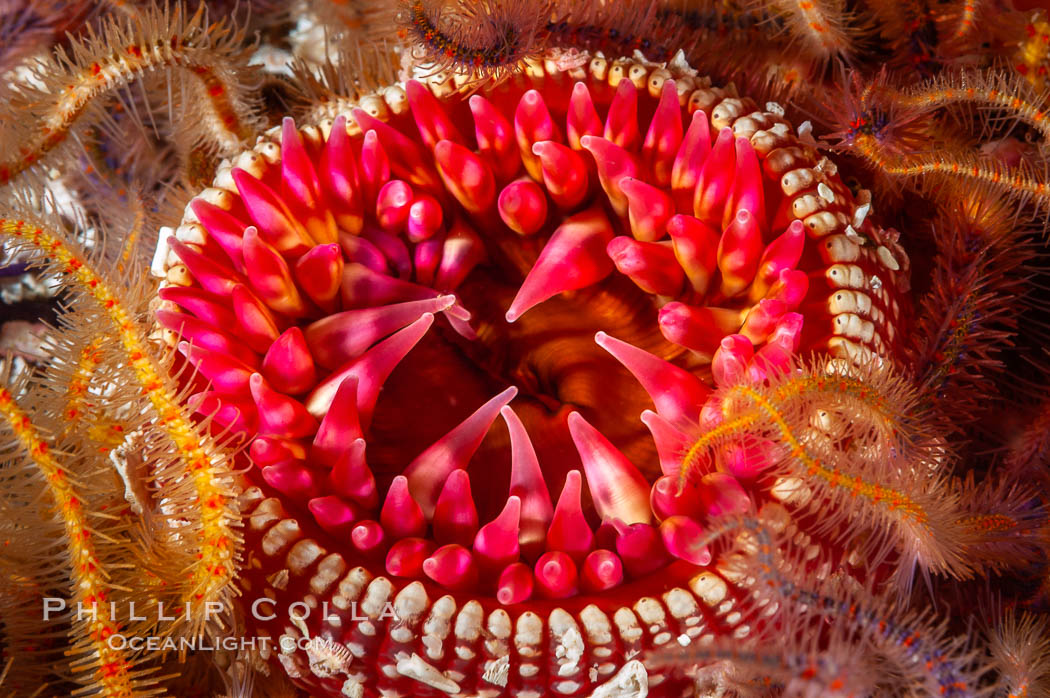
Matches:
[[368, 268, 663, 522]]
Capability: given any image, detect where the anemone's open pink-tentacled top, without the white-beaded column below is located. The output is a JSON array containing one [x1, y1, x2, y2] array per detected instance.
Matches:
[[158, 47, 907, 692]]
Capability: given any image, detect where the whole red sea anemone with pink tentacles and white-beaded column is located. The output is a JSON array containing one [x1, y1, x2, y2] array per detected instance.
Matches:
[[155, 27, 978, 695]]
